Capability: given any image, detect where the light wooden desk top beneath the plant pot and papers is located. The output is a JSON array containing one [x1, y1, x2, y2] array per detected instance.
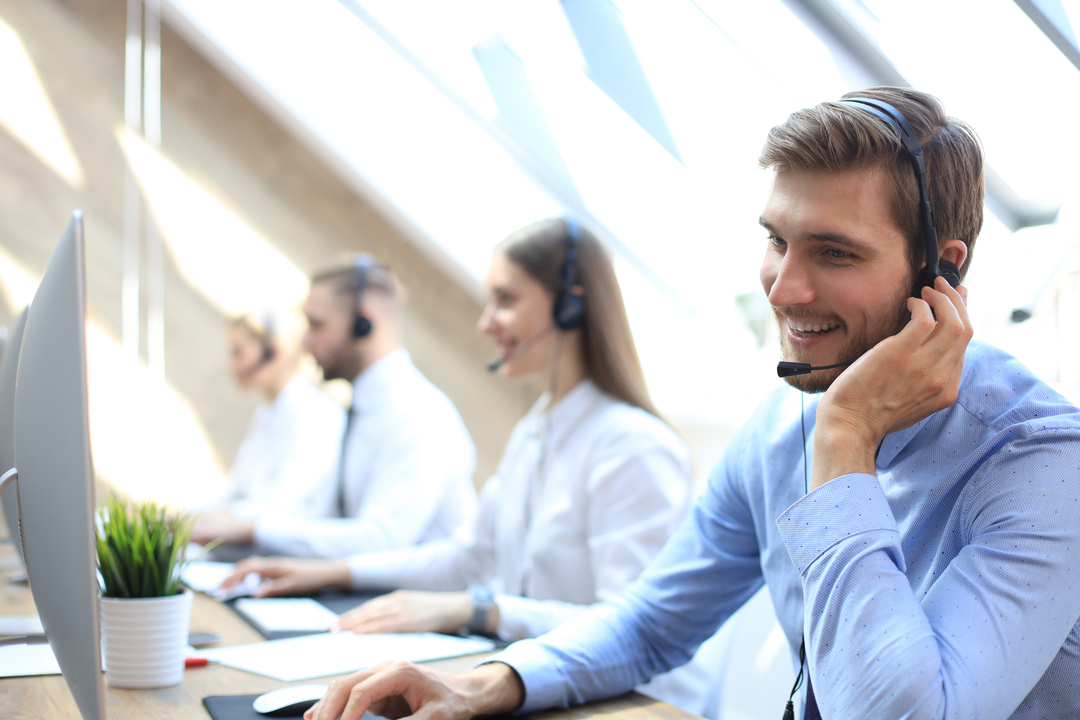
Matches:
[[0, 544, 700, 720]]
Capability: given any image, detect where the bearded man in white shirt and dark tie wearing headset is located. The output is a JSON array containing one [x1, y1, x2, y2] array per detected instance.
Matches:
[[199, 255, 477, 557]]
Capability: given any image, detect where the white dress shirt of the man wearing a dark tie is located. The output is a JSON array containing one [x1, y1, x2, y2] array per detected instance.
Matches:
[[255, 349, 477, 557]]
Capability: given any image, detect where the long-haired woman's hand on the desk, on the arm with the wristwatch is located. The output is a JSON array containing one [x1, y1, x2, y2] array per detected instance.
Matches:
[[333, 590, 499, 635]]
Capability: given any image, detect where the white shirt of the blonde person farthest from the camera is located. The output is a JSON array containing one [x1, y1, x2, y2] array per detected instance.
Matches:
[[227, 375, 345, 518]]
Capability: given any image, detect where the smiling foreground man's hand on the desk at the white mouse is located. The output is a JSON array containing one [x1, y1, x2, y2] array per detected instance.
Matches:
[[303, 661, 525, 720]]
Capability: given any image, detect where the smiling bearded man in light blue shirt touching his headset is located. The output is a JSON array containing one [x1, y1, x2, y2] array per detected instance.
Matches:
[[307, 89, 1080, 720]]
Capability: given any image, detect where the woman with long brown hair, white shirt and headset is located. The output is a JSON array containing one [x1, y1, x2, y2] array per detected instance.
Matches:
[[226, 219, 734, 712]]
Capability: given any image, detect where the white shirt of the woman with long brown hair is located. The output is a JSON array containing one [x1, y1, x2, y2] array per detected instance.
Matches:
[[349, 380, 730, 711]]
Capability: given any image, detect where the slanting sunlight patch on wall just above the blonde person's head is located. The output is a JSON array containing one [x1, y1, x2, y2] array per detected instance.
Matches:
[[117, 128, 308, 317]]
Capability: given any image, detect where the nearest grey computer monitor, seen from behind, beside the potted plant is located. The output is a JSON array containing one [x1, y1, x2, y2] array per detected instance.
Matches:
[[15, 210, 105, 720]]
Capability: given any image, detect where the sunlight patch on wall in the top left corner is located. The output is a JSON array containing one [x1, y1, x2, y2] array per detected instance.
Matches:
[[0, 19, 85, 190]]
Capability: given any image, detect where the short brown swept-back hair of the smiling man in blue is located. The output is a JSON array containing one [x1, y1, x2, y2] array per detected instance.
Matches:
[[758, 87, 985, 277]]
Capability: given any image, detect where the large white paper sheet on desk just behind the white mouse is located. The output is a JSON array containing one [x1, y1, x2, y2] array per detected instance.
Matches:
[[203, 630, 495, 682]]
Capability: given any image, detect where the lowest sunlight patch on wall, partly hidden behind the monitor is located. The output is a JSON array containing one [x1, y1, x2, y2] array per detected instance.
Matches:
[[0, 248, 226, 507]]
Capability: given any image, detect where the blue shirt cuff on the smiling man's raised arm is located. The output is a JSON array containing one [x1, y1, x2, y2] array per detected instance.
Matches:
[[777, 473, 900, 576]]
